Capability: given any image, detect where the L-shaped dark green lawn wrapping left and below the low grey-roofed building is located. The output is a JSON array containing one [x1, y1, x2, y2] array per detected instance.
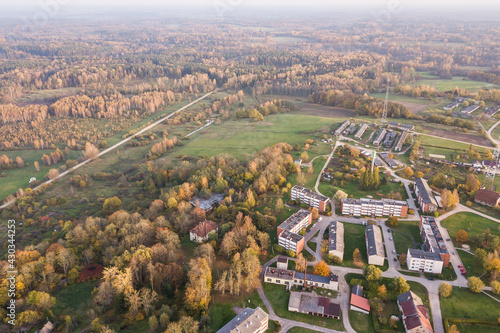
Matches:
[[263, 283, 344, 331]]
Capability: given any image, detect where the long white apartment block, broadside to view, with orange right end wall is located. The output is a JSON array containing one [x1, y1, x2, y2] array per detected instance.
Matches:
[[340, 198, 408, 217]]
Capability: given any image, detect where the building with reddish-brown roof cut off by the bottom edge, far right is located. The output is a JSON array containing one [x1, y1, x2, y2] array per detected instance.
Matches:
[[398, 291, 433, 333]]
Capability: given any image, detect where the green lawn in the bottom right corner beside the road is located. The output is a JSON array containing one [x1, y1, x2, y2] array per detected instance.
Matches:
[[440, 287, 500, 320]]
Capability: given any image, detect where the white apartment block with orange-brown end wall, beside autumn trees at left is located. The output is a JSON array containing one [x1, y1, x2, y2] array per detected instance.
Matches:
[[277, 209, 312, 253]]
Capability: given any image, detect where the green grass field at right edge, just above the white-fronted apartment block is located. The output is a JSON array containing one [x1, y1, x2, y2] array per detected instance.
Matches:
[[441, 213, 500, 242]]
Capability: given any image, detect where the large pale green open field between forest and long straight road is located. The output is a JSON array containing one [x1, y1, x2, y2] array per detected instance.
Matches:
[[176, 113, 337, 159]]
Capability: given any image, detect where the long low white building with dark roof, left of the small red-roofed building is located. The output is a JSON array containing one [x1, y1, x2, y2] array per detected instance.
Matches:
[[264, 267, 339, 291]]
